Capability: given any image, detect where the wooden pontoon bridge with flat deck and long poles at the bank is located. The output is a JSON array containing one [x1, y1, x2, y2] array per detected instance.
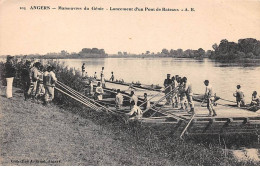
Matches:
[[55, 79, 260, 138]]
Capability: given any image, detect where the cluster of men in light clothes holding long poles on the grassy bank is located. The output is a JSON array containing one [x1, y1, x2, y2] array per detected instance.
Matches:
[[21, 60, 57, 104]]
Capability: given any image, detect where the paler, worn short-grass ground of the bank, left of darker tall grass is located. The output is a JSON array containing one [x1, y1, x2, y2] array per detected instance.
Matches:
[[0, 87, 174, 165]]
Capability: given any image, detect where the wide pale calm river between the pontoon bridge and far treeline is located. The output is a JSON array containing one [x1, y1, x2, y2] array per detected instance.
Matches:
[[60, 58, 260, 102]]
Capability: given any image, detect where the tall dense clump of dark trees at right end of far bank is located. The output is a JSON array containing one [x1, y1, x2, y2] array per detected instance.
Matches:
[[209, 38, 260, 61]]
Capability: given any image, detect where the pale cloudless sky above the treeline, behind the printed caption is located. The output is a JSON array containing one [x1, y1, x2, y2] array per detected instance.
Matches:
[[0, 0, 260, 55]]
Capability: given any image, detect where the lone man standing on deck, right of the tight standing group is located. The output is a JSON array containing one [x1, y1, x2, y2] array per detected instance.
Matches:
[[204, 80, 217, 116]]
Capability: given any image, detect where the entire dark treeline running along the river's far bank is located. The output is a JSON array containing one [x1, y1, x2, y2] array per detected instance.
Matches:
[[1, 38, 260, 62]]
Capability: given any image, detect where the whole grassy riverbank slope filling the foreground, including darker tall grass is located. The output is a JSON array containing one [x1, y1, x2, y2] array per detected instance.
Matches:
[[0, 87, 259, 165]]
